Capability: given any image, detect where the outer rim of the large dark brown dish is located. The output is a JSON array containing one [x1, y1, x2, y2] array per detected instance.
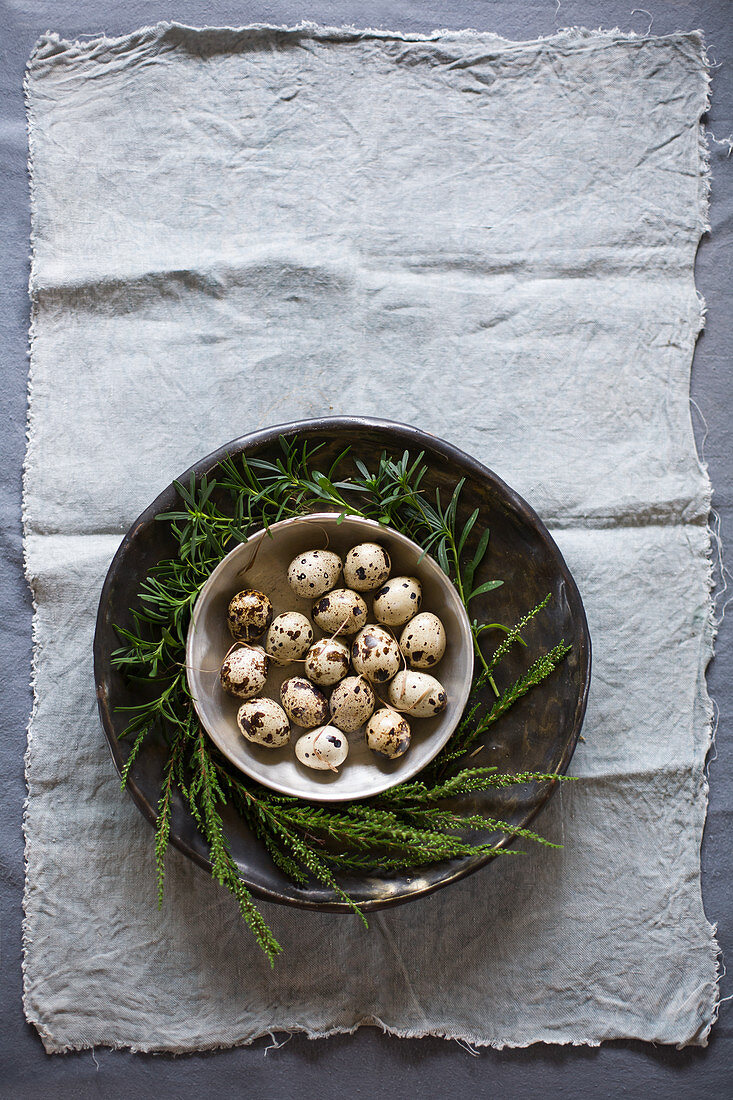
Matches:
[[94, 415, 592, 914]]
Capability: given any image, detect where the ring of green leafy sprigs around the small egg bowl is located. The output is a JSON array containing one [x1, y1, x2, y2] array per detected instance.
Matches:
[[112, 438, 570, 963]]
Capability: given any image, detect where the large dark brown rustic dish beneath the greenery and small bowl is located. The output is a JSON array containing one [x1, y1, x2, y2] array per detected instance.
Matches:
[[95, 417, 591, 912]]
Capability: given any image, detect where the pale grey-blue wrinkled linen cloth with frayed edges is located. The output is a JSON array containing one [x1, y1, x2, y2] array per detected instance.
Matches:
[[24, 24, 716, 1052]]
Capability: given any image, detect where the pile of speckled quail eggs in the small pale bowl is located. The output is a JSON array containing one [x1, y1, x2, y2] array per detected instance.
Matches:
[[214, 542, 448, 772]]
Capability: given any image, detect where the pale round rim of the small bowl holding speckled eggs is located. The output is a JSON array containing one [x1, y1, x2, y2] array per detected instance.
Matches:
[[186, 512, 473, 802]]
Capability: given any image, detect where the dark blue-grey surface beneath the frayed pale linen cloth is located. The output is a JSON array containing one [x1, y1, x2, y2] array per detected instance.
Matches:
[[0, 0, 733, 1098]]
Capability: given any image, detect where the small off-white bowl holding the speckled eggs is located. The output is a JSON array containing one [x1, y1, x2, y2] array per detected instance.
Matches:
[[186, 513, 473, 802]]
